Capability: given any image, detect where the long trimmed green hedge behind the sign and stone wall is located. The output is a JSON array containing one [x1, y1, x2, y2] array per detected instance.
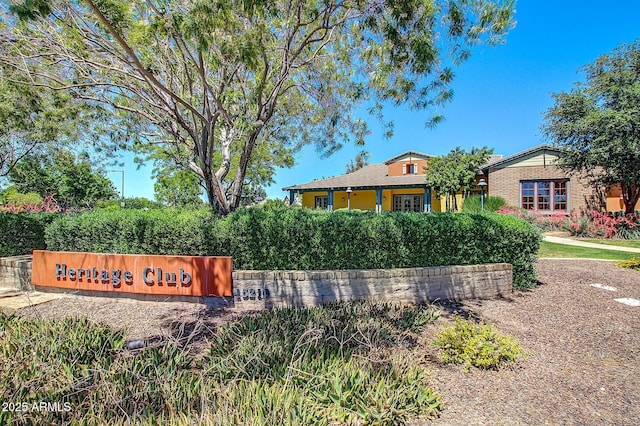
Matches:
[[46, 207, 541, 288]]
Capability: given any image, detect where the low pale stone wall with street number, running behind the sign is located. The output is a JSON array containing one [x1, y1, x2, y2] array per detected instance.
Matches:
[[0, 256, 513, 310]]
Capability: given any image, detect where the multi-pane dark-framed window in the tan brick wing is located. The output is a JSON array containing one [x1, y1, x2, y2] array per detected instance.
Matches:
[[520, 180, 568, 212]]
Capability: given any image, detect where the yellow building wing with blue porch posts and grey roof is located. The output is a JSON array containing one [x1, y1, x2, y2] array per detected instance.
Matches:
[[283, 151, 441, 212]]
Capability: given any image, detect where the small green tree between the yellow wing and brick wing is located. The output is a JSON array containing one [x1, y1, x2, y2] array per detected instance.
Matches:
[[425, 146, 493, 211]]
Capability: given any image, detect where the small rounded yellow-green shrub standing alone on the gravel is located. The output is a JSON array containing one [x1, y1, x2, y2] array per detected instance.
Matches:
[[433, 317, 524, 371]]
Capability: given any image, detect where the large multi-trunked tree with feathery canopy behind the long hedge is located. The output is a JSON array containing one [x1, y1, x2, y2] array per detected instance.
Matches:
[[0, 0, 514, 213]]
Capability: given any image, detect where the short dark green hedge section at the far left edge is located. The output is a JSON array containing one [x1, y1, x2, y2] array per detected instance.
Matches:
[[0, 212, 59, 257]]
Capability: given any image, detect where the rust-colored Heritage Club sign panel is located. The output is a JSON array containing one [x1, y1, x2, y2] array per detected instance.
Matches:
[[31, 250, 232, 296]]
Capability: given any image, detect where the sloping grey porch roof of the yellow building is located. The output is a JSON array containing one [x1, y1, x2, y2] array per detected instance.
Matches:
[[282, 164, 426, 191]]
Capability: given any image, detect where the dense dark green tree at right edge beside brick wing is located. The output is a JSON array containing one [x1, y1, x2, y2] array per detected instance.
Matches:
[[543, 42, 640, 213]]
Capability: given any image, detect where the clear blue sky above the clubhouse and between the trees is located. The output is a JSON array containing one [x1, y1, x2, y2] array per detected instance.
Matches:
[[109, 0, 640, 199]]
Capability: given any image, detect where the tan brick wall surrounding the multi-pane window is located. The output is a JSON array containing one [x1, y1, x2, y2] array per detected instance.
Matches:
[[489, 165, 600, 212]]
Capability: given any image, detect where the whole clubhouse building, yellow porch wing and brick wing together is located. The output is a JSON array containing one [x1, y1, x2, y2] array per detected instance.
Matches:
[[283, 144, 640, 215]]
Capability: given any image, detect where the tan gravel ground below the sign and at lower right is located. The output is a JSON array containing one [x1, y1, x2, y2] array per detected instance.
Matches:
[[12, 260, 640, 425]]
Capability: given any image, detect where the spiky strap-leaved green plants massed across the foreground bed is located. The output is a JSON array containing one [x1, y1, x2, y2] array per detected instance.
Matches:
[[0, 302, 442, 425]]
